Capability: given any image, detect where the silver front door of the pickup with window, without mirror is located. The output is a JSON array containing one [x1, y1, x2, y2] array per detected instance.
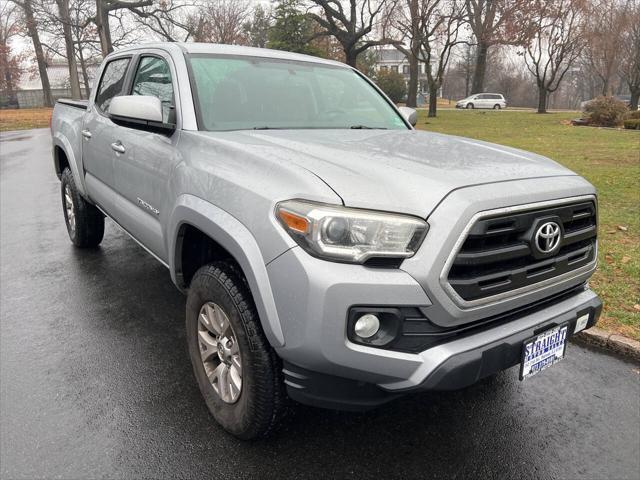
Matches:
[[114, 52, 181, 263]]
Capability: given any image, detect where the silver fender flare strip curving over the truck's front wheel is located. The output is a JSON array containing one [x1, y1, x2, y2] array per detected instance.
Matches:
[[167, 195, 284, 347]]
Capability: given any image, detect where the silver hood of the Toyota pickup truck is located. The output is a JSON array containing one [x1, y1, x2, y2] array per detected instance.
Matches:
[[195, 130, 575, 218]]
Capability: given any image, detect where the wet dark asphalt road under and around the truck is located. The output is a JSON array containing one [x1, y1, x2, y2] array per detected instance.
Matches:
[[0, 130, 640, 479]]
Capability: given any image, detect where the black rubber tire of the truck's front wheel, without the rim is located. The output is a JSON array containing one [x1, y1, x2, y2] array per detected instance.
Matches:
[[186, 262, 286, 440]]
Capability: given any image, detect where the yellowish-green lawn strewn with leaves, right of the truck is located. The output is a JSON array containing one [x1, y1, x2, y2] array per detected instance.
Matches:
[[417, 110, 640, 340]]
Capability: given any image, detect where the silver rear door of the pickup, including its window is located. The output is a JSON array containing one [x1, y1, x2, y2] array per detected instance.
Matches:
[[81, 56, 131, 215]]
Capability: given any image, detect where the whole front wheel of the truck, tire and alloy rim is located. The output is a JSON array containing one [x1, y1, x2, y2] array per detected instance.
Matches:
[[186, 262, 285, 440]]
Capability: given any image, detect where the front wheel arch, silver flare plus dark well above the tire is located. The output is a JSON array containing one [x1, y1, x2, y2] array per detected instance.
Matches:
[[168, 195, 284, 347]]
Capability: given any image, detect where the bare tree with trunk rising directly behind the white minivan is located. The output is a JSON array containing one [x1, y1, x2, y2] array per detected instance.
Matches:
[[465, 0, 531, 93]]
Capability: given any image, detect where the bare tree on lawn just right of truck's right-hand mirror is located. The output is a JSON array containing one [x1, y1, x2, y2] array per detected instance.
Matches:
[[418, 0, 465, 117]]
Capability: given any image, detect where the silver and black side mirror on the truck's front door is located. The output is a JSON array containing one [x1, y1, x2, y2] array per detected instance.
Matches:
[[109, 95, 175, 133]]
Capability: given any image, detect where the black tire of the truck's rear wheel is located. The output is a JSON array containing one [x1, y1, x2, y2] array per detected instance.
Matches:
[[60, 167, 104, 248]]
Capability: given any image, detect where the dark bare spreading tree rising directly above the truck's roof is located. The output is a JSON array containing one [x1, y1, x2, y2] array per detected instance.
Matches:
[[309, 0, 395, 67]]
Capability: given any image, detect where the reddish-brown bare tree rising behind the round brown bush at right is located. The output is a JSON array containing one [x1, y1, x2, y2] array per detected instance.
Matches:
[[584, 0, 628, 95]]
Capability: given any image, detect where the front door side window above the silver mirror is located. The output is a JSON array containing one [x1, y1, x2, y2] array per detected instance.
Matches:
[[131, 57, 176, 123]]
